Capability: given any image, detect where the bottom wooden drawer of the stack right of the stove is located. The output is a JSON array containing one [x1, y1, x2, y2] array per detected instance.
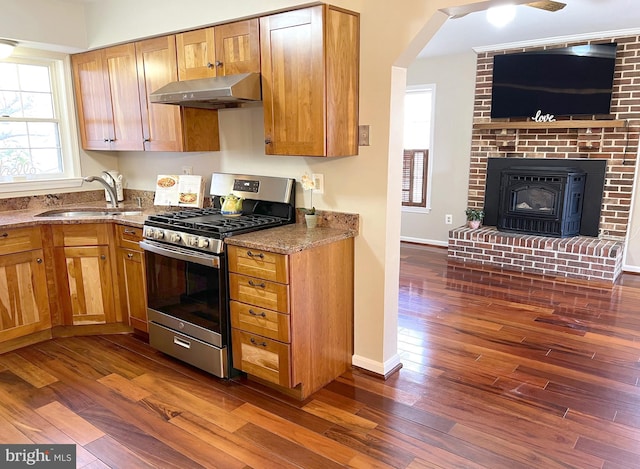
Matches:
[[231, 329, 292, 388]]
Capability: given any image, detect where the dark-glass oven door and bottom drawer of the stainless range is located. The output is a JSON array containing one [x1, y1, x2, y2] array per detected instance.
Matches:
[[140, 240, 229, 378]]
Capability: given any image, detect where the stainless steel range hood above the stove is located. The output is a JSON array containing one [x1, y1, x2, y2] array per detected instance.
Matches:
[[149, 73, 262, 109]]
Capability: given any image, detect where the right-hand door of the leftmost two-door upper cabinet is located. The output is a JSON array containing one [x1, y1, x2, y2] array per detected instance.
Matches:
[[103, 44, 144, 151]]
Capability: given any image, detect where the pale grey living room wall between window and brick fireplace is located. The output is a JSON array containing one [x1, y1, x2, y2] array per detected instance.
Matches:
[[401, 51, 476, 246]]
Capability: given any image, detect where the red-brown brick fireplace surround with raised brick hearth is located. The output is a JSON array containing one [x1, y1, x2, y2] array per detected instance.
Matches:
[[448, 36, 640, 284]]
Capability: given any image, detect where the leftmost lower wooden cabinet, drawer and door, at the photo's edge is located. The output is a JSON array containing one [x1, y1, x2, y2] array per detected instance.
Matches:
[[0, 227, 51, 343]]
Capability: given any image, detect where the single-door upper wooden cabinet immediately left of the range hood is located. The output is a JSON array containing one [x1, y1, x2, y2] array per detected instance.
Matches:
[[135, 35, 220, 151]]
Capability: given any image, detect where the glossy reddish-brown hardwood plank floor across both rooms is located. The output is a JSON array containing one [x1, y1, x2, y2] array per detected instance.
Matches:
[[0, 245, 640, 469]]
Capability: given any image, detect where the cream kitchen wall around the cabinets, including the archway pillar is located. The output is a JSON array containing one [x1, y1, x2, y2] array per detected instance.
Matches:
[[0, 0, 484, 373]]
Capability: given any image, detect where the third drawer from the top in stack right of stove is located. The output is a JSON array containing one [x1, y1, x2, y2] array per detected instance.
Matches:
[[231, 301, 290, 342]]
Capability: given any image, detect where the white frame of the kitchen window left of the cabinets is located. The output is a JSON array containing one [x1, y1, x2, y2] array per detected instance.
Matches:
[[0, 47, 82, 197]]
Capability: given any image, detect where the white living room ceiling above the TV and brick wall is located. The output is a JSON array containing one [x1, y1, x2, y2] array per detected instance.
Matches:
[[419, 0, 640, 58]]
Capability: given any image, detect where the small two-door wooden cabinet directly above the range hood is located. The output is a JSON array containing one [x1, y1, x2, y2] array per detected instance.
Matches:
[[176, 18, 260, 81]]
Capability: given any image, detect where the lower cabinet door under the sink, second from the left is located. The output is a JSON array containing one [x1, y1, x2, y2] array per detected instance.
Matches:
[[55, 246, 116, 326]]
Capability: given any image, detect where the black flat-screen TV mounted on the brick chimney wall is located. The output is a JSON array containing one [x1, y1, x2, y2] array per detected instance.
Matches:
[[491, 43, 617, 118]]
